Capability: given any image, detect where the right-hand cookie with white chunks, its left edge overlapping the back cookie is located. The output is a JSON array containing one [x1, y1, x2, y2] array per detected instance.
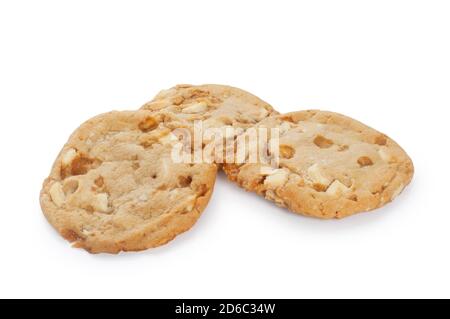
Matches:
[[224, 110, 414, 219]]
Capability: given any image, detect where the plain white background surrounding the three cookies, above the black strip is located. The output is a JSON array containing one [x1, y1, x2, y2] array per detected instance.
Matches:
[[0, 0, 450, 298]]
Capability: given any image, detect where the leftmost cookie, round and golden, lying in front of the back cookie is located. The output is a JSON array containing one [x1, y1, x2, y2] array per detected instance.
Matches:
[[40, 110, 217, 253]]
